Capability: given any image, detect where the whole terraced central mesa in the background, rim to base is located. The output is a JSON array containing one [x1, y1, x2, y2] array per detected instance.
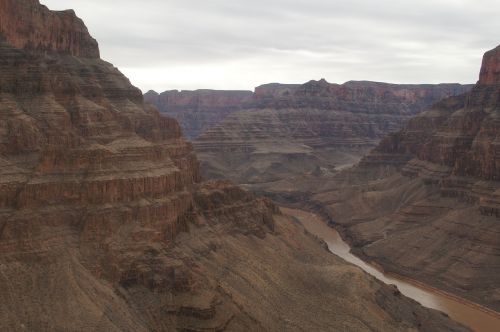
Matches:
[[194, 80, 470, 186]]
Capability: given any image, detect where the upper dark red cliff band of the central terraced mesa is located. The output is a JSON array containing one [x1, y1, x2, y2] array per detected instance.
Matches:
[[252, 79, 472, 115]]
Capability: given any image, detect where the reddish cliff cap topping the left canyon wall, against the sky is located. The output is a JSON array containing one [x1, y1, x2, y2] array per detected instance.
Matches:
[[0, 0, 99, 58]]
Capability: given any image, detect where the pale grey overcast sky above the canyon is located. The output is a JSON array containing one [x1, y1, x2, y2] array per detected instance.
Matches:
[[41, 0, 500, 92]]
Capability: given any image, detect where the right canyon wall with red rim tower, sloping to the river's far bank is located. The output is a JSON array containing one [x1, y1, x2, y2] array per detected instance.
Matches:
[[270, 47, 500, 311]]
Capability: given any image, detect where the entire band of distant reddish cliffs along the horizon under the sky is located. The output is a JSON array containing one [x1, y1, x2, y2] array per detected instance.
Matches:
[[149, 80, 472, 139]]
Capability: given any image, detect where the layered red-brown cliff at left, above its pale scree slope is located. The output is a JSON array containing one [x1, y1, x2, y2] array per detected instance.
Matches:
[[0, 0, 199, 288]]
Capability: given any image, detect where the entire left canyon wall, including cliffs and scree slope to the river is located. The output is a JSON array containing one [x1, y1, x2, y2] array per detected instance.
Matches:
[[0, 0, 472, 331]]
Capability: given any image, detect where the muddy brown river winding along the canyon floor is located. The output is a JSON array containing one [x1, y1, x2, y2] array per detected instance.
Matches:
[[281, 207, 500, 332]]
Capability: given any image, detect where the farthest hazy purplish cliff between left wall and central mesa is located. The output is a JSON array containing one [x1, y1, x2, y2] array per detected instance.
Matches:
[[144, 90, 252, 138]]
